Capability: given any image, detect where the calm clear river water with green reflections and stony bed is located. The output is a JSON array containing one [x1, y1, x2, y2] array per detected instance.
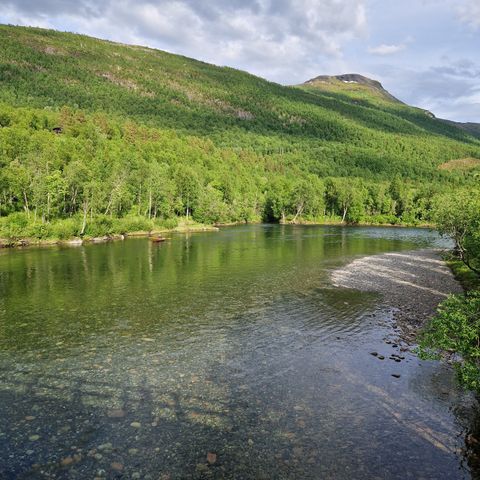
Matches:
[[0, 226, 476, 480]]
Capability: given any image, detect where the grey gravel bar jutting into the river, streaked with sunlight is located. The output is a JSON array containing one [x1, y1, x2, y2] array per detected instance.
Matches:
[[331, 250, 462, 343]]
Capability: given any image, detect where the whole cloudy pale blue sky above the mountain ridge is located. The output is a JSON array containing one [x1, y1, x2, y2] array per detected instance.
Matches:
[[0, 0, 480, 123]]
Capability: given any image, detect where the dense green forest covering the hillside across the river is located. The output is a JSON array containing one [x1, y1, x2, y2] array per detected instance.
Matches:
[[0, 26, 480, 239]]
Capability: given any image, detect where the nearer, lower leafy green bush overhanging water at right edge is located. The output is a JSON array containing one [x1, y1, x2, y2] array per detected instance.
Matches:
[[420, 291, 480, 393]]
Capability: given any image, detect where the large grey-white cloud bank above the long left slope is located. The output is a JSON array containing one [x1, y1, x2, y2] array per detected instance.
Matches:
[[3, 0, 368, 83]]
